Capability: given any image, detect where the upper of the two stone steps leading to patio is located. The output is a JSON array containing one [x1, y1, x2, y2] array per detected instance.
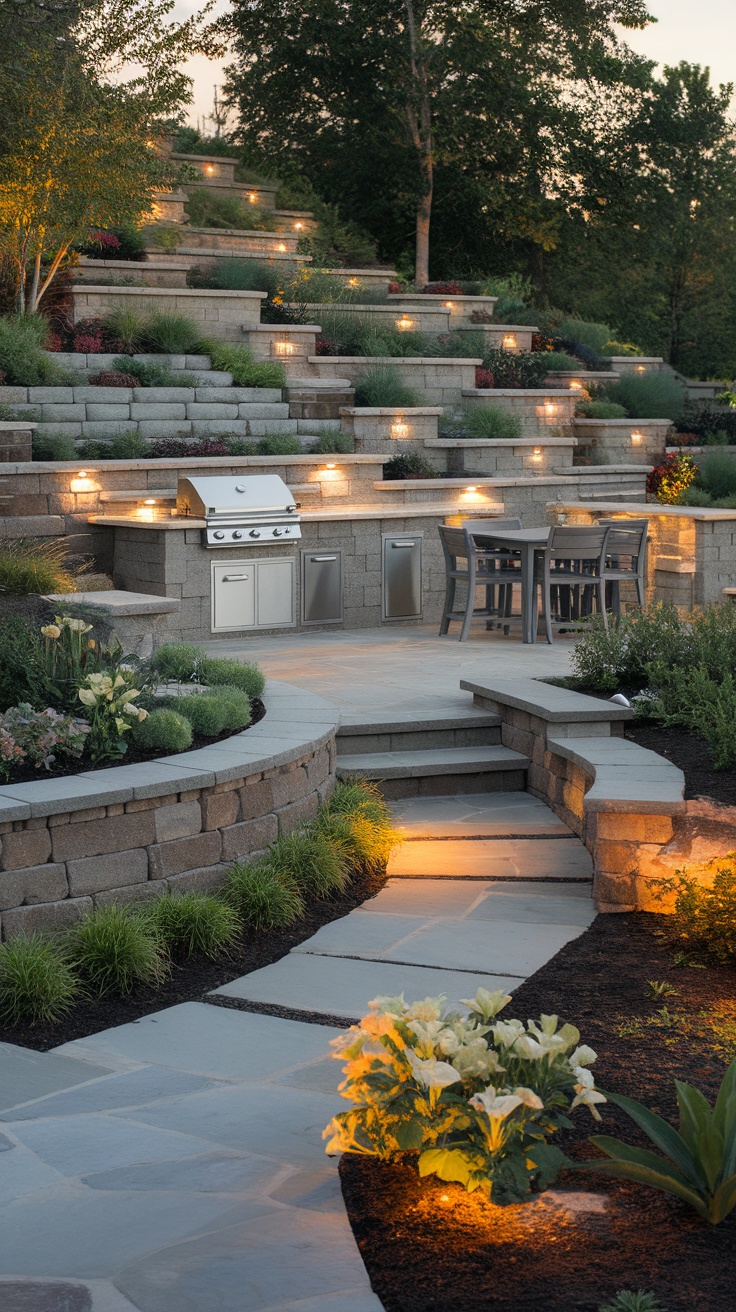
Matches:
[[337, 711, 501, 758]]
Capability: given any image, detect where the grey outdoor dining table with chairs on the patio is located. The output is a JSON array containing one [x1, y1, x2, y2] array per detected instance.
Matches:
[[438, 517, 649, 643]]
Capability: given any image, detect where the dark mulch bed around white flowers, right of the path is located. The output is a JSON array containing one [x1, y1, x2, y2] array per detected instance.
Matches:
[[340, 914, 736, 1312]]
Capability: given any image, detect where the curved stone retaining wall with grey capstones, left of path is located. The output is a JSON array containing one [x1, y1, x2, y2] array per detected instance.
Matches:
[[0, 684, 340, 939]]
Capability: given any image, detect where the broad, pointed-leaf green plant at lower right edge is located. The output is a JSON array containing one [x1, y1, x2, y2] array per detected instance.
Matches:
[[580, 1060, 736, 1225]]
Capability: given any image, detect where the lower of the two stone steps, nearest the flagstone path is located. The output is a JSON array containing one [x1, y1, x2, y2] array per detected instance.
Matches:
[[338, 744, 530, 798]]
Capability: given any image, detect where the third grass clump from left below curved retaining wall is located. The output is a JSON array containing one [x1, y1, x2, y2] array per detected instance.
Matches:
[[142, 892, 243, 958]]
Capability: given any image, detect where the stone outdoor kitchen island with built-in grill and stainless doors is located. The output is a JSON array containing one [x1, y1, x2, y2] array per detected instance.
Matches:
[[84, 476, 502, 642]]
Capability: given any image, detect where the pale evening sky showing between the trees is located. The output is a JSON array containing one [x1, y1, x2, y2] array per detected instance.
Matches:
[[174, 0, 736, 123]]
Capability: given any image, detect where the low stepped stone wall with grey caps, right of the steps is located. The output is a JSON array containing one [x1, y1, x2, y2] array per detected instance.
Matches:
[[460, 678, 689, 912]]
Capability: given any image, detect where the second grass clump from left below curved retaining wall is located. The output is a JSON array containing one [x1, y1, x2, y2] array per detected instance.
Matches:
[[67, 904, 167, 994]]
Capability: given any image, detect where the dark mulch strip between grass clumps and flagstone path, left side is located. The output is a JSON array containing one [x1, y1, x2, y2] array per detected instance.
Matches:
[[0, 871, 386, 1052]]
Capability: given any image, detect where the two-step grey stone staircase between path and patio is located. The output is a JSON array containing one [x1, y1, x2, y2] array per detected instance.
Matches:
[[337, 707, 530, 798]]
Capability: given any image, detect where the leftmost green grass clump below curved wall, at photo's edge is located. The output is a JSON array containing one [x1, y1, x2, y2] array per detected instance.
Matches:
[[0, 934, 80, 1027]]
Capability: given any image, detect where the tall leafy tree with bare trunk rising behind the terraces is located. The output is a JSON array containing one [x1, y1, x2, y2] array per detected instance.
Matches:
[[227, 0, 648, 285]]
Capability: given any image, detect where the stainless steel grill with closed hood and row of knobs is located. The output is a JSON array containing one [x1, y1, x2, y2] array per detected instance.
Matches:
[[176, 474, 302, 547]]
